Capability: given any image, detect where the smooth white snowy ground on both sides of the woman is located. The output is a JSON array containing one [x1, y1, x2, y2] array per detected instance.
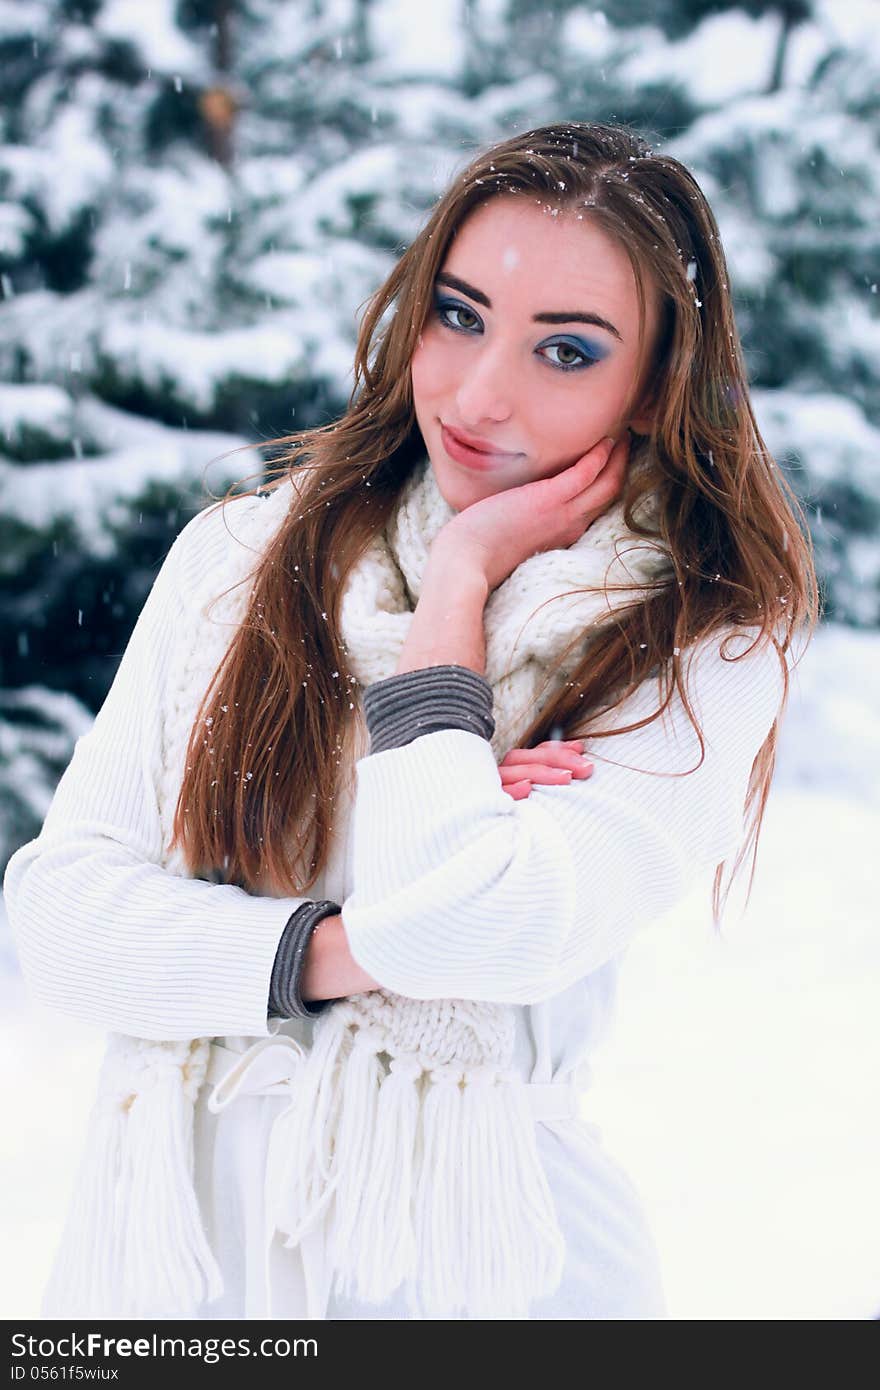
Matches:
[[0, 627, 880, 1319]]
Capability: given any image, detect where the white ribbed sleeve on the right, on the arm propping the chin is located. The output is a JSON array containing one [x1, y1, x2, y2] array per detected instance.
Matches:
[[342, 630, 783, 1004]]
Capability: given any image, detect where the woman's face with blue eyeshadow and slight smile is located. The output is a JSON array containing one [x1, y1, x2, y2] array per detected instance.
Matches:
[[412, 195, 658, 512]]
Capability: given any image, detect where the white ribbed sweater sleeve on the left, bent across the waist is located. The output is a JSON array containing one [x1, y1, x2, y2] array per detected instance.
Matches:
[[3, 512, 310, 1040]]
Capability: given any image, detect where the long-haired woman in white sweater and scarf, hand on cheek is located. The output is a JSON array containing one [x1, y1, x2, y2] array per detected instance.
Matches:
[[6, 124, 817, 1319]]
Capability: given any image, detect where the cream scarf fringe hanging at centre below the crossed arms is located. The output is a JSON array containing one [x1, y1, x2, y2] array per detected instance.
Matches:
[[267, 1006, 564, 1319]]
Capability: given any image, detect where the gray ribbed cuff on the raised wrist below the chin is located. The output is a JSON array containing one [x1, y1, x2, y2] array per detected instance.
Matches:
[[363, 663, 495, 753]]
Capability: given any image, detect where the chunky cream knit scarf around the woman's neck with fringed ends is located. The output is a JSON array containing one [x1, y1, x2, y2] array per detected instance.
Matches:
[[42, 457, 671, 1318]]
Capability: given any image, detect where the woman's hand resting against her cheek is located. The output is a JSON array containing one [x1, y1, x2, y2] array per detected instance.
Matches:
[[434, 431, 630, 592]]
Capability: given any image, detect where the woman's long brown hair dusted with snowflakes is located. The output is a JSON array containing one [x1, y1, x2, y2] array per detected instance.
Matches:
[[168, 122, 820, 926]]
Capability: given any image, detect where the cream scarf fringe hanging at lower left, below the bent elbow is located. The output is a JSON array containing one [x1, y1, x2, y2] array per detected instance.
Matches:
[[40, 1038, 222, 1318]]
